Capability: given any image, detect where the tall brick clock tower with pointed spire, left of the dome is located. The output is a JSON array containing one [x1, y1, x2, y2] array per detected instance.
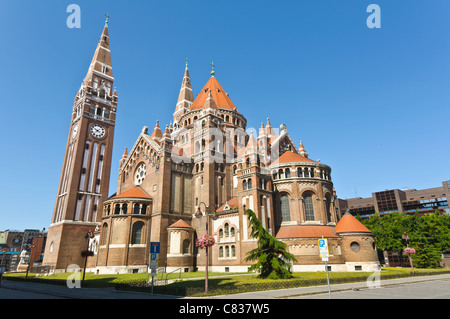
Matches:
[[43, 20, 118, 271]]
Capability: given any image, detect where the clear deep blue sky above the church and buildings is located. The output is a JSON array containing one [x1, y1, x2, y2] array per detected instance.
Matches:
[[0, 0, 450, 230]]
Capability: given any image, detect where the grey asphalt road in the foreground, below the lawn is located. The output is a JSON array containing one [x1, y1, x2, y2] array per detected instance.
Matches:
[[0, 274, 450, 301]]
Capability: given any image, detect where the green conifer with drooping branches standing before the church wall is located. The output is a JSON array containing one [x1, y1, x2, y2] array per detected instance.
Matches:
[[244, 209, 297, 279]]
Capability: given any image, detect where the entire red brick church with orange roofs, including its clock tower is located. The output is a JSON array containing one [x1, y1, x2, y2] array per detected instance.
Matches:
[[44, 23, 379, 273]]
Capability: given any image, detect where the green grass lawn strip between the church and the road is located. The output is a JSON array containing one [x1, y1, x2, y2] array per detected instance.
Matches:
[[4, 268, 449, 296]]
